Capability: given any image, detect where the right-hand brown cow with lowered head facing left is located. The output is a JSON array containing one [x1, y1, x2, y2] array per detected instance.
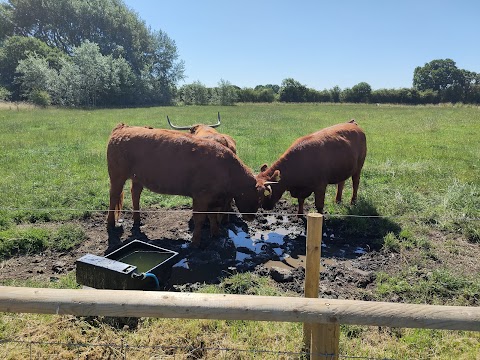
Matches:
[[260, 120, 367, 214]]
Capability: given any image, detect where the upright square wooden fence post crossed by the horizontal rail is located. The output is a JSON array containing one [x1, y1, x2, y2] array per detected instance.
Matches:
[[303, 213, 340, 360]]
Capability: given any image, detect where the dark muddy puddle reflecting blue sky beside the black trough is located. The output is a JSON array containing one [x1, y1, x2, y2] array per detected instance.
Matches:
[[172, 215, 367, 284]]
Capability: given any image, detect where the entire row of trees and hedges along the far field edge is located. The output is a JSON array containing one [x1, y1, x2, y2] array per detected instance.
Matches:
[[0, 0, 480, 106]]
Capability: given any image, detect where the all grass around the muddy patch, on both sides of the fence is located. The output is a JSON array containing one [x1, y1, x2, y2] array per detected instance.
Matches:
[[0, 104, 480, 359]]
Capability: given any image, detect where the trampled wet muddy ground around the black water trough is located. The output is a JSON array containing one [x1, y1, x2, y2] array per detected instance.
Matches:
[[0, 201, 480, 302]]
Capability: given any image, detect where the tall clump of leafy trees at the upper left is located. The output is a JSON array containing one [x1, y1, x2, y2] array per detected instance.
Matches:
[[0, 0, 184, 106]]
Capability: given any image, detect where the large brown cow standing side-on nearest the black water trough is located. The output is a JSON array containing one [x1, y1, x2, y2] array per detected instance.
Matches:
[[107, 124, 278, 246]]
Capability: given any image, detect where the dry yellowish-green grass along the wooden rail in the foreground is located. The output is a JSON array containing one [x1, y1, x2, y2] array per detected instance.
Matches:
[[0, 274, 480, 360]]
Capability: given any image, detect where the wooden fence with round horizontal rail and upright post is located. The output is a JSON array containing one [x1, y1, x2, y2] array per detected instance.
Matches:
[[0, 214, 480, 359]]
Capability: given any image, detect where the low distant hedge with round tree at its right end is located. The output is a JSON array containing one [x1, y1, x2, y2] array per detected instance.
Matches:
[[177, 63, 480, 105]]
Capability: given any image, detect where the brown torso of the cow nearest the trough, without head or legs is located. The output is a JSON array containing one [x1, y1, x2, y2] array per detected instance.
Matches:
[[107, 125, 239, 196]]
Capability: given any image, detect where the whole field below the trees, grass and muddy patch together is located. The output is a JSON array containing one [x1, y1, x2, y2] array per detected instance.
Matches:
[[0, 104, 480, 359]]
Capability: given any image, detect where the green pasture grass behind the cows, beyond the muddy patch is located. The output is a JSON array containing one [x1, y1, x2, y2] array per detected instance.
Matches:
[[0, 104, 480, 226]]
